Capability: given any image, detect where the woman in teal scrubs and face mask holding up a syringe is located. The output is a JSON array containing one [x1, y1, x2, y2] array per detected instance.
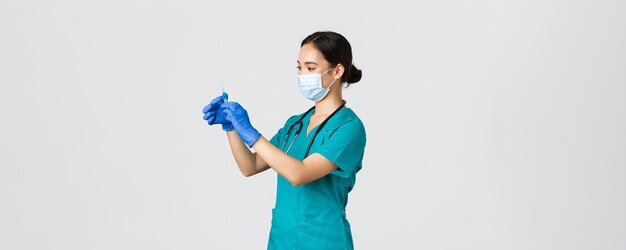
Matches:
[[203, 31, 366, 250]]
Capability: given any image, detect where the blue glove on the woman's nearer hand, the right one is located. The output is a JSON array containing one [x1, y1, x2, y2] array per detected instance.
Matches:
[[222, 102, 261, 148]]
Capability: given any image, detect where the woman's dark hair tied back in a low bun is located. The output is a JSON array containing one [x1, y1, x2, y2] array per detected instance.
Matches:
[[300, 31, 362, 86]]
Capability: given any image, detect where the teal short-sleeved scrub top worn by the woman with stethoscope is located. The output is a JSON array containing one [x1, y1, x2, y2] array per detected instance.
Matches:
[[267, 107, 366, 250]]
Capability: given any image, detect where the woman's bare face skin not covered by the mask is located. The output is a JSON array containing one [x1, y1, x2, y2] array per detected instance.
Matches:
[[297, 43, 337, 87]]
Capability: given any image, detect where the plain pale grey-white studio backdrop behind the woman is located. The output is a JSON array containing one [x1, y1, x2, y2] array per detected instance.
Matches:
[[0, 0, 626, 250]]
